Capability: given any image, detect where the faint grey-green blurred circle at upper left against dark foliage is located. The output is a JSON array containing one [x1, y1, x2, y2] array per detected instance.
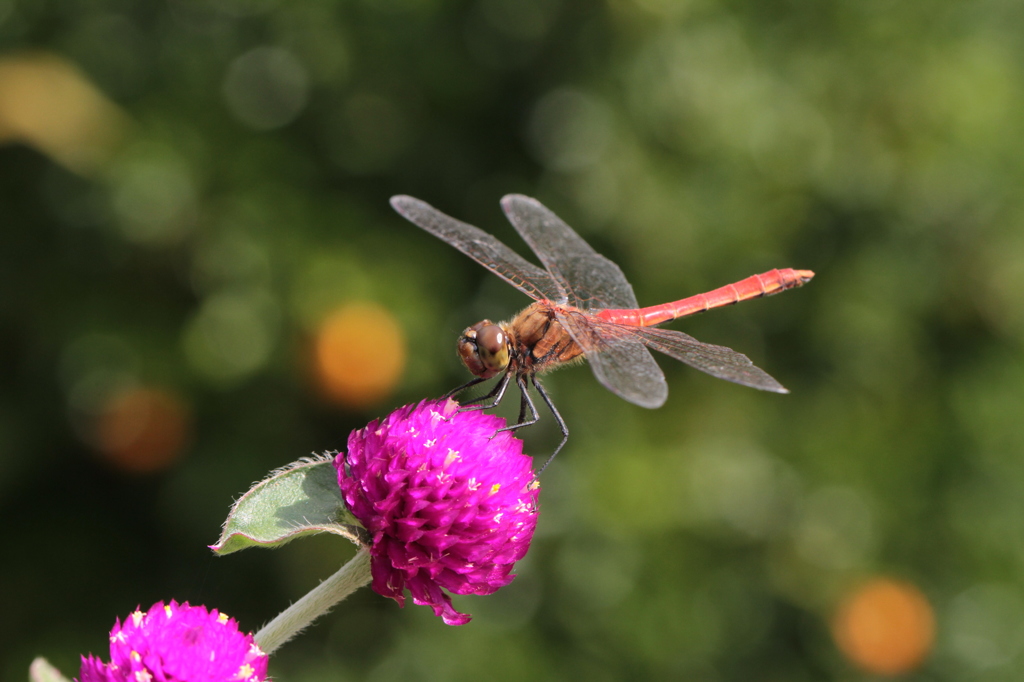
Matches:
[[223, 46, 309, 130]]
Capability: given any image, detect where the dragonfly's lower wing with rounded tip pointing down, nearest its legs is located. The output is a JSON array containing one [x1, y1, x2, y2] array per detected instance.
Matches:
[[555, 311, 669, 409]]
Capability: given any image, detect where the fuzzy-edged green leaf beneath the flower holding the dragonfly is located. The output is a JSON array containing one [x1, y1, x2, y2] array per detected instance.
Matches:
[[210, 455, 369, 554]]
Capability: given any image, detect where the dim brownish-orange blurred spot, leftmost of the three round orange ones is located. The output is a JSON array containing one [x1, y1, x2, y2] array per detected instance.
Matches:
[[95, 388, 191, 474]]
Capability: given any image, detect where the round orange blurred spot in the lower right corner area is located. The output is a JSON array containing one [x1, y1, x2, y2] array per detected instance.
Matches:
[[833, 578, 935, 675]]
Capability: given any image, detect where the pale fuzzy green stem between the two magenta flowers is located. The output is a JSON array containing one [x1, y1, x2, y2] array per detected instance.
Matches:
[[254, 548, 370, 654]]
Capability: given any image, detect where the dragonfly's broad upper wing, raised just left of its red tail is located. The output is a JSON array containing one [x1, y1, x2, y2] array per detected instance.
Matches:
[[502, 195, 640, 309]]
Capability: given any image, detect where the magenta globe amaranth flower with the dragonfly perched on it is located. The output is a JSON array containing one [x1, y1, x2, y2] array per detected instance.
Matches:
[[335, 399, 540, 625]]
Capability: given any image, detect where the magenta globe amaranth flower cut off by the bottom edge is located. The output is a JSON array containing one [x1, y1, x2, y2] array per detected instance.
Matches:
[[77, 601, 267, 682]]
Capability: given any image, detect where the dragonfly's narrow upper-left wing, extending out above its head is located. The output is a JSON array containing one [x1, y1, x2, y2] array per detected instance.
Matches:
[[391, 195, 567, 301]]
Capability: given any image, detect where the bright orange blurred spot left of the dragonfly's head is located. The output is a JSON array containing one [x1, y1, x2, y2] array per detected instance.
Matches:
[[315, 302, 407, 408]]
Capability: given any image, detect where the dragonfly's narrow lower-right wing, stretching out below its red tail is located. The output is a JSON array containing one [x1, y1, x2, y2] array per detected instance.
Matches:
[[626, 324, 790, 393]]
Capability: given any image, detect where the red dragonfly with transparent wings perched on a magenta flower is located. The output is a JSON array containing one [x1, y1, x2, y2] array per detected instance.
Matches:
[[391, 195, 814, 466]]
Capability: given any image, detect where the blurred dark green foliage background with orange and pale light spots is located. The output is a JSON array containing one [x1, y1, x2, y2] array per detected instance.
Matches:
[[0, 0, 1024, 682]]
